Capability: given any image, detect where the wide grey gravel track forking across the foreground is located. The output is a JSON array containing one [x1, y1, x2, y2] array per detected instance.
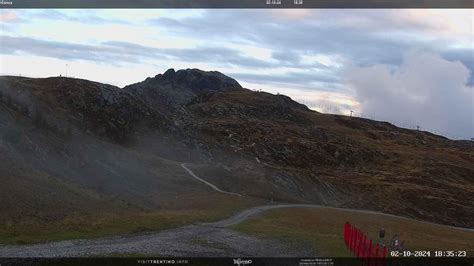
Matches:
[[0, 205, 317, 257]]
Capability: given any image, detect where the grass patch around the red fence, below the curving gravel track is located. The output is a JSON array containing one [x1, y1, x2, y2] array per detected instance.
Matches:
[[234, 207, 474, 257]]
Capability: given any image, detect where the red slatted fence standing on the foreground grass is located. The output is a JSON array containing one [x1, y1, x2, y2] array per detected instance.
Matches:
[[344, 222, 388, 266]]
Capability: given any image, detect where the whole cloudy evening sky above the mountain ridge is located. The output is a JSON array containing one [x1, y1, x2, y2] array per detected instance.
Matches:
[[0, 9, 474, 139]]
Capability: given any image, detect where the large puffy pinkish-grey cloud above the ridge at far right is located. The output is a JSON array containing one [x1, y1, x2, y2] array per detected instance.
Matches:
[[346, 51, 474, 139]]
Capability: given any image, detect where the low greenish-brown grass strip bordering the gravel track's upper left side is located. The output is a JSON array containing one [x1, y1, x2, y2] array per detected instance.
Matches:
[[0, 192, 259, 244]]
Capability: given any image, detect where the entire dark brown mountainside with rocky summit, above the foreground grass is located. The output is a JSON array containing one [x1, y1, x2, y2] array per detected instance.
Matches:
[[0, 69, 474, 228]]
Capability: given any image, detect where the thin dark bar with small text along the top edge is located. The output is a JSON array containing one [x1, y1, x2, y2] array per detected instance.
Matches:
[[0, 0, 474, 8]]
